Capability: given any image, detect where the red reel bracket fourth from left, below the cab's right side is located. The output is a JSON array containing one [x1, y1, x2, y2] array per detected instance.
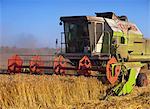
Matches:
[[78, 56, 92, 76]]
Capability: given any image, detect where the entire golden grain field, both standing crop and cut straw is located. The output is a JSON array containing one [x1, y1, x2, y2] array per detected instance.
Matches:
[[0, 74, 150, 109]]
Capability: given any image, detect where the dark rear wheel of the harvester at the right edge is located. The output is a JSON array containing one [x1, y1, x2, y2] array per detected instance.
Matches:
[[136, 73, 148, 87]]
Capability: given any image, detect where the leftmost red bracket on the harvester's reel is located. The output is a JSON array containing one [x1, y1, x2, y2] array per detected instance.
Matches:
[[8, 55, 23, 74]]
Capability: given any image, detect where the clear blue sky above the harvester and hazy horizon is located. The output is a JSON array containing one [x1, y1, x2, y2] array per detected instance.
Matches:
[[0, 0, 150, 47]]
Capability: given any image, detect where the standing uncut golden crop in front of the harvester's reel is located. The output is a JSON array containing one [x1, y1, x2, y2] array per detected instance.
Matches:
[[0, 75, 105, 109]]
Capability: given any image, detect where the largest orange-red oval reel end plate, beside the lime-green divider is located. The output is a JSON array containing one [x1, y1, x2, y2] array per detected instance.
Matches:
[[106, 57, 121, 84]]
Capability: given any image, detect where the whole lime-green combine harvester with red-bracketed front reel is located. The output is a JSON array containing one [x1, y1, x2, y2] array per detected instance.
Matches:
[[8, 12, 150, 95]]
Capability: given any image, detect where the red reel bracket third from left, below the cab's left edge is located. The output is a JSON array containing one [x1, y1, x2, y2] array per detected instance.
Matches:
[[53, 55, 67, 75]]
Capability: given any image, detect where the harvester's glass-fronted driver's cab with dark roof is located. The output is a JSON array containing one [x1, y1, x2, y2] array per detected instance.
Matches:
[[60, 16, 111, 55]]
